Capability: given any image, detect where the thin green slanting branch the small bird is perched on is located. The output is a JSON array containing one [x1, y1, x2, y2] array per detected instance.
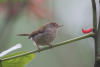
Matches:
[[1, 33, 94, 61]]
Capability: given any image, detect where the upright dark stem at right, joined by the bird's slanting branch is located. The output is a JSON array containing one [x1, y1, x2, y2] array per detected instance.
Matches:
[[91, 0, 98, 67]]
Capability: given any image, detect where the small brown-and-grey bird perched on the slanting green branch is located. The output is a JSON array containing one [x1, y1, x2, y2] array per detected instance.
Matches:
[[18, 22, 63, 52]]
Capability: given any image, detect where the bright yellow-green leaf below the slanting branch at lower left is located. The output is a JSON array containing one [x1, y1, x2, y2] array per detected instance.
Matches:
[[2, 52, 35, 67]]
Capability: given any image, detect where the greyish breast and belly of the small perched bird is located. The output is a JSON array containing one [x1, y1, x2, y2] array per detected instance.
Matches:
[[34, 31, 56, 45]]
